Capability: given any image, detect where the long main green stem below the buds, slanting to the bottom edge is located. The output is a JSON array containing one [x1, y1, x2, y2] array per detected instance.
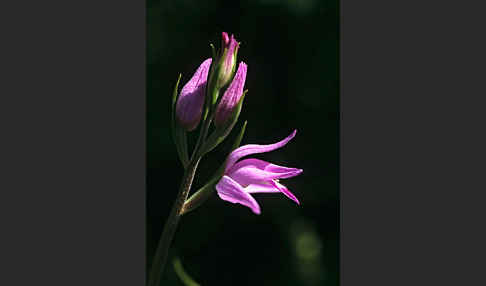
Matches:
[[148, 158, 201, 286]]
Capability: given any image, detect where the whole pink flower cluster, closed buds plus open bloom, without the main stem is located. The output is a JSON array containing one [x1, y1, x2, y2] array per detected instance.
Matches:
[[175, 32, 302, 214]]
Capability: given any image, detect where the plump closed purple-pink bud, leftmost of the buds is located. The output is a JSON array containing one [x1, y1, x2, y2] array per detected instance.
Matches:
[[176, 58, 211, 131]]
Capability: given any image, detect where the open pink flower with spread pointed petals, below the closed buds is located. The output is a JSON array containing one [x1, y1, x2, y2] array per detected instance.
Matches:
[[216, 130, 302, 214]]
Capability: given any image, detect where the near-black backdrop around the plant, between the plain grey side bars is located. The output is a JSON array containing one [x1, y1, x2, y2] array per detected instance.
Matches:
[[147, 0, 339, 285]]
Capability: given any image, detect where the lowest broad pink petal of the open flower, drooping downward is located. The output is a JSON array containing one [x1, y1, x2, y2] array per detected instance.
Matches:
[[216, 176, 260, 214]]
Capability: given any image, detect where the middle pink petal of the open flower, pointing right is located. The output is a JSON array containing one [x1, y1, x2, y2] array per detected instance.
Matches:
[[227, 159, 302, 186]]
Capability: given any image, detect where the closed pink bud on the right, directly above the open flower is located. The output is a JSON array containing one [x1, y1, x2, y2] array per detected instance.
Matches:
[[214, 62, 247, 127]]
